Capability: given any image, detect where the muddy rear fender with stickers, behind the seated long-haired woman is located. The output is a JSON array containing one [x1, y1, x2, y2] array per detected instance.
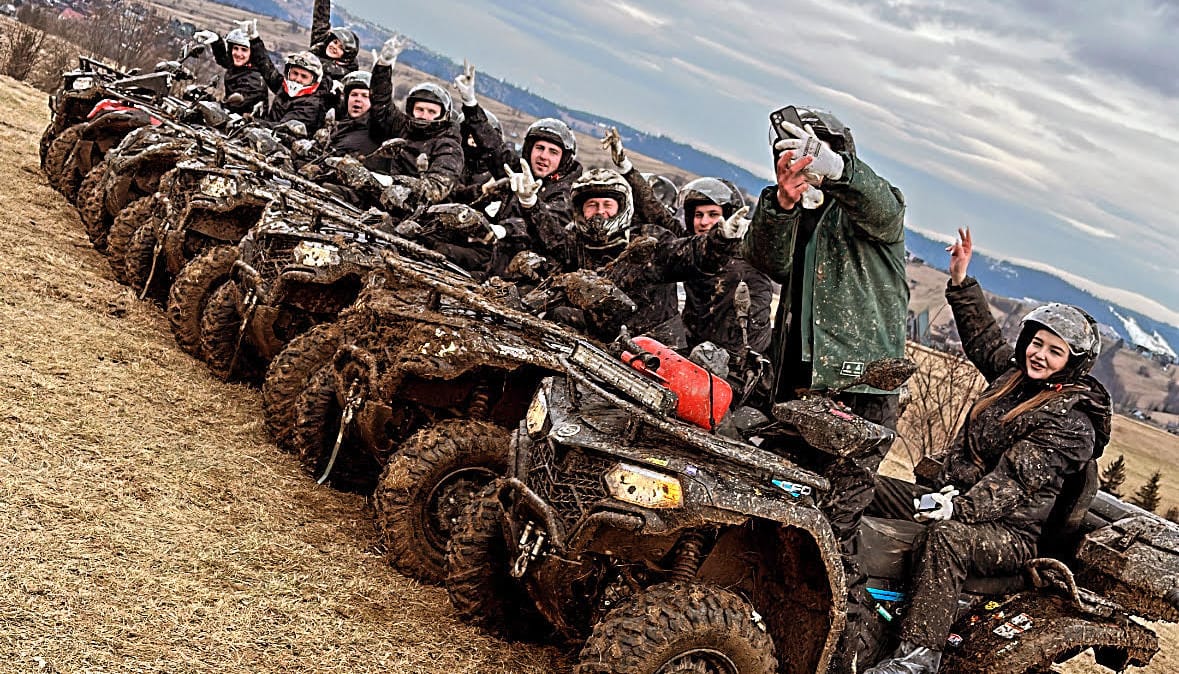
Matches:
[[940, 590, 1159, 674]]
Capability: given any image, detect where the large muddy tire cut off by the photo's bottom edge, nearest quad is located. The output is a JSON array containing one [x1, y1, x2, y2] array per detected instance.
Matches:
[[575, 583, 778, 674]]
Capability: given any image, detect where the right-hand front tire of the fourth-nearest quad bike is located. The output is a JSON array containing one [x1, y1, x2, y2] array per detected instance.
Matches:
[[166, 246, 237, 358]]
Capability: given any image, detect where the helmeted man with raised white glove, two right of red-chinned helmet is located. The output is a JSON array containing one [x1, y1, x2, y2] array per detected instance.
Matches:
[[369, 35, 462, 204]]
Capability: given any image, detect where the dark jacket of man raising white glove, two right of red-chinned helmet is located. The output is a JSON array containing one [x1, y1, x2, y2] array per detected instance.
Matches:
[[369, 65, 462, 204]]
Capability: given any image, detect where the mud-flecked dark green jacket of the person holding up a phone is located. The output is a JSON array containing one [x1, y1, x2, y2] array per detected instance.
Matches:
[[742, 154, 909, 396]]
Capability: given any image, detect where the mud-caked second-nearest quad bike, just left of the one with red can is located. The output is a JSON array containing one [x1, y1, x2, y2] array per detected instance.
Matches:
[[287, 256, 617, 582]]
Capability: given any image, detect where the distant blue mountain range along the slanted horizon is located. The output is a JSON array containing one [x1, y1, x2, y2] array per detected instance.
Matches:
[[224, 0, 1179, 353]]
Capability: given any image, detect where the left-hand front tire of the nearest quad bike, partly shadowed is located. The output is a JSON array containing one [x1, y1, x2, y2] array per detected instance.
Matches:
[[446, 482, 551, 641]]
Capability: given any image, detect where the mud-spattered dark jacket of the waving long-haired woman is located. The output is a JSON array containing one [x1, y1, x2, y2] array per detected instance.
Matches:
[[940, 278, 1111, 541]]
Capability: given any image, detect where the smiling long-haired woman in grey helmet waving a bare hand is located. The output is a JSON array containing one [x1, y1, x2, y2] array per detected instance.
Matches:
[[868, 230, 1112, 674]]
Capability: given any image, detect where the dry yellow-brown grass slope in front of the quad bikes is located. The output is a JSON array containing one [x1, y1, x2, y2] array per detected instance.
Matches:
[[0, 78, 565, 673]]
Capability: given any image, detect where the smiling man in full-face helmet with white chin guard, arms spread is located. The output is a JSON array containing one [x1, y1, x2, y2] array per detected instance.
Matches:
[[500, 169, 749, 346]]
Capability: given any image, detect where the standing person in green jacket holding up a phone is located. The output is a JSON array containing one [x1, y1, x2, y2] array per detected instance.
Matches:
[[742, 107, 909, 662]]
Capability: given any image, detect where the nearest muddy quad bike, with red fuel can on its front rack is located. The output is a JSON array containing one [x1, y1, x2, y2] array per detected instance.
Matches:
[[447, 338, 1173, 674]]
